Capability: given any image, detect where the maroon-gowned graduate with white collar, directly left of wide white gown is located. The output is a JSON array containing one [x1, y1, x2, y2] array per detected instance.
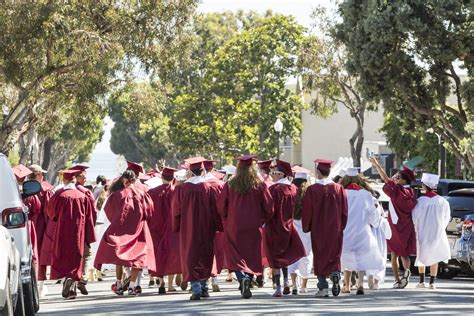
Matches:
[[302, 159, 348, 297]]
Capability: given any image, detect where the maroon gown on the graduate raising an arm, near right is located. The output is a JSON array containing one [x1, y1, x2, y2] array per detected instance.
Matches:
[[383, 179, 416, 257]]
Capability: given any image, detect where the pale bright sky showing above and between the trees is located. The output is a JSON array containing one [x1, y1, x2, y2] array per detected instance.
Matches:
[[84, 0, 335, 180]]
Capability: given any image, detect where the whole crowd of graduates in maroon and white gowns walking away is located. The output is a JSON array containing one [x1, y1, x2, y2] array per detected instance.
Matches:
[[14, 155, 450, 300]]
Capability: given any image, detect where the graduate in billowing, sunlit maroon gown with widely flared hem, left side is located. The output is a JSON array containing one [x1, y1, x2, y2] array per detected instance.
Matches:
[[94, 170, 156, 296]]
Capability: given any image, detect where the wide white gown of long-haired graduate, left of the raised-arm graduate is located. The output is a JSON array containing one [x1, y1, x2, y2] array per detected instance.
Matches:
[[341, 189, 385, 271]]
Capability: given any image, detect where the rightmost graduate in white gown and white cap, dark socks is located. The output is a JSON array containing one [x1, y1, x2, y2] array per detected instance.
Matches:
[[412, 173, 451, 290]]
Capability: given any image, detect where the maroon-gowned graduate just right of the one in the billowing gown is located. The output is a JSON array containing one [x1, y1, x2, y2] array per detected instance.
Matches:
[[148, 167, 181, 294]]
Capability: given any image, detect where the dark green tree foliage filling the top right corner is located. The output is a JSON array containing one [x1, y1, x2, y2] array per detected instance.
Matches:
[[337, 0, 474, 172]]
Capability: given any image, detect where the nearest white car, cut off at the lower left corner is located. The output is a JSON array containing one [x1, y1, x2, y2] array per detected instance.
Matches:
[[0, 226, 24, 316]]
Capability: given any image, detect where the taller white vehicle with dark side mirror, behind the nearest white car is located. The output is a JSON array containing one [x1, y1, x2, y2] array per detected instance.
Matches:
[[0, 153, 41, 315]]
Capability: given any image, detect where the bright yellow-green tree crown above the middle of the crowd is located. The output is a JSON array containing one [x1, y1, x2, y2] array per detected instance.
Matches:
[[170, 15, 303, 158]]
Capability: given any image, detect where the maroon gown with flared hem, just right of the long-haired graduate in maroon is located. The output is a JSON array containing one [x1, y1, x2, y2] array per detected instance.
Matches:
[[264, 183, 306, 269]]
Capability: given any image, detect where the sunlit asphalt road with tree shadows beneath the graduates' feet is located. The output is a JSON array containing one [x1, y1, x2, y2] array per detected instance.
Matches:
[[40, 271, 474, 315]]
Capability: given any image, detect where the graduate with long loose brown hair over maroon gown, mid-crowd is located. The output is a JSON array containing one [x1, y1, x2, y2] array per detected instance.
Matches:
[[217, 155, 273, 298]]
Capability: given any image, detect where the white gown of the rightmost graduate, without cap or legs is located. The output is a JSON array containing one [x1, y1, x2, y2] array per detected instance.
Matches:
[[412, 195, 451, 266]]
